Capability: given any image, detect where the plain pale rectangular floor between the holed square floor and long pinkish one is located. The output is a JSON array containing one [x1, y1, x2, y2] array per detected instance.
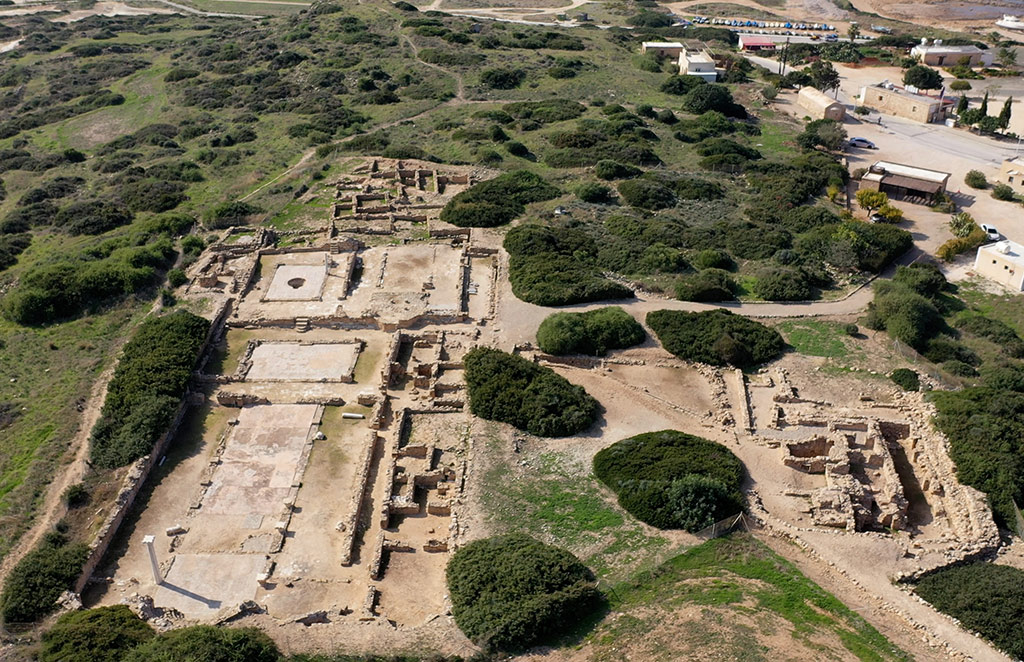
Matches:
[[246, 342, 360, 381]]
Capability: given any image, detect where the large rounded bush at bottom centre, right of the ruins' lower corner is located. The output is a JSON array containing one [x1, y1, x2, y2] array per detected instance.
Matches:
[[446, 534, 601, 652]]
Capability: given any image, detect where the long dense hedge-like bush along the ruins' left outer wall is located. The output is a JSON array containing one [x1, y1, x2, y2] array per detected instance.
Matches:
[[90, 311, 210, 468]]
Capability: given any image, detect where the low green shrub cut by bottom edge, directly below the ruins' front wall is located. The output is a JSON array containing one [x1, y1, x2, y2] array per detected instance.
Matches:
[[123, 625, 285, 662]]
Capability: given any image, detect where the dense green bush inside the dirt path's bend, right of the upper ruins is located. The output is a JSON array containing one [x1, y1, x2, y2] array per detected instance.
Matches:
[[505, 224, 633, 305]]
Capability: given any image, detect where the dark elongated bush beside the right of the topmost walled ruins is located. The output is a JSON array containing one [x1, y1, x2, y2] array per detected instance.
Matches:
[[440, 170, 560, 227]]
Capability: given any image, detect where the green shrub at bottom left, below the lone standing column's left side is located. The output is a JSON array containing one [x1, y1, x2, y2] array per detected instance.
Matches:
[[39, 605, 156, 662]]
